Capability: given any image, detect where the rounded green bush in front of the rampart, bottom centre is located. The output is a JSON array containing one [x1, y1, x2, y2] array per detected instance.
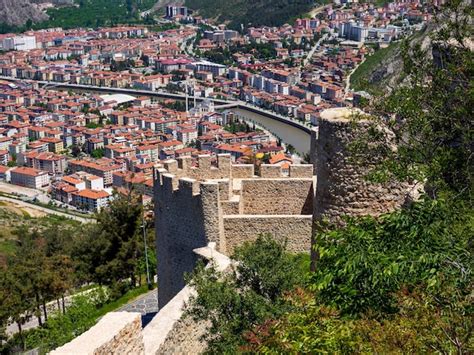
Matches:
[[188, 236, 308, 353]]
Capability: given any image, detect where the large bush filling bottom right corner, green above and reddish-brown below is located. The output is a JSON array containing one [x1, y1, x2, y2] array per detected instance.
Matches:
[[244, 199, 474, 354]]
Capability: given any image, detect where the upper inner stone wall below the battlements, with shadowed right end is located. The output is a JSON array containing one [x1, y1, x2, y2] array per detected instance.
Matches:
[[240, 178, 313, 215]]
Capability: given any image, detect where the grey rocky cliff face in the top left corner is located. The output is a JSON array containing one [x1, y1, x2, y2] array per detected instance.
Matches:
[[0, 0, 48, 26]]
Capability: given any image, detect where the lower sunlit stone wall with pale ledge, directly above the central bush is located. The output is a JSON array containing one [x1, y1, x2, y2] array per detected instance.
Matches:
[[224, 215, 313, 255]]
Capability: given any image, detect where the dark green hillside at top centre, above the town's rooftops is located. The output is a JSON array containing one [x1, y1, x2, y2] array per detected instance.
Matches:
[[186, 0, 323, 29]]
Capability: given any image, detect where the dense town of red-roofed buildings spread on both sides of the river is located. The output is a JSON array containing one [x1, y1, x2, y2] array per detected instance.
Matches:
[[0, 1, 431, 211]]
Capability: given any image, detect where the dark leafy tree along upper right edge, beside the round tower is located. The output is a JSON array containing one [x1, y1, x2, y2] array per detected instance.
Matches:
[[353, 0, 474, 197]]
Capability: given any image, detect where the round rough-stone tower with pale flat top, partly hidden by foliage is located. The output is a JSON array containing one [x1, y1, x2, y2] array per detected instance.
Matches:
[[311, 108, 408, 222]]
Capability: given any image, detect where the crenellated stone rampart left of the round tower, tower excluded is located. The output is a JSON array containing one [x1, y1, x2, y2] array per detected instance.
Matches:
[[154, 154, 313, 307]]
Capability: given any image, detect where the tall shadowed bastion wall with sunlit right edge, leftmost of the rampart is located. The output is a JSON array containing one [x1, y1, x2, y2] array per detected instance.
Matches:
[[154, 169, 224, 308]]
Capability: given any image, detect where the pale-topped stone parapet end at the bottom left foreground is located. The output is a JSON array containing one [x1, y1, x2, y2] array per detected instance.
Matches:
[[50, 312, 144, 355]]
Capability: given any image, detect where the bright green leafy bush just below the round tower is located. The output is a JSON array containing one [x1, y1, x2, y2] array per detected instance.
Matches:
[[311, 199, 474, 315]]
